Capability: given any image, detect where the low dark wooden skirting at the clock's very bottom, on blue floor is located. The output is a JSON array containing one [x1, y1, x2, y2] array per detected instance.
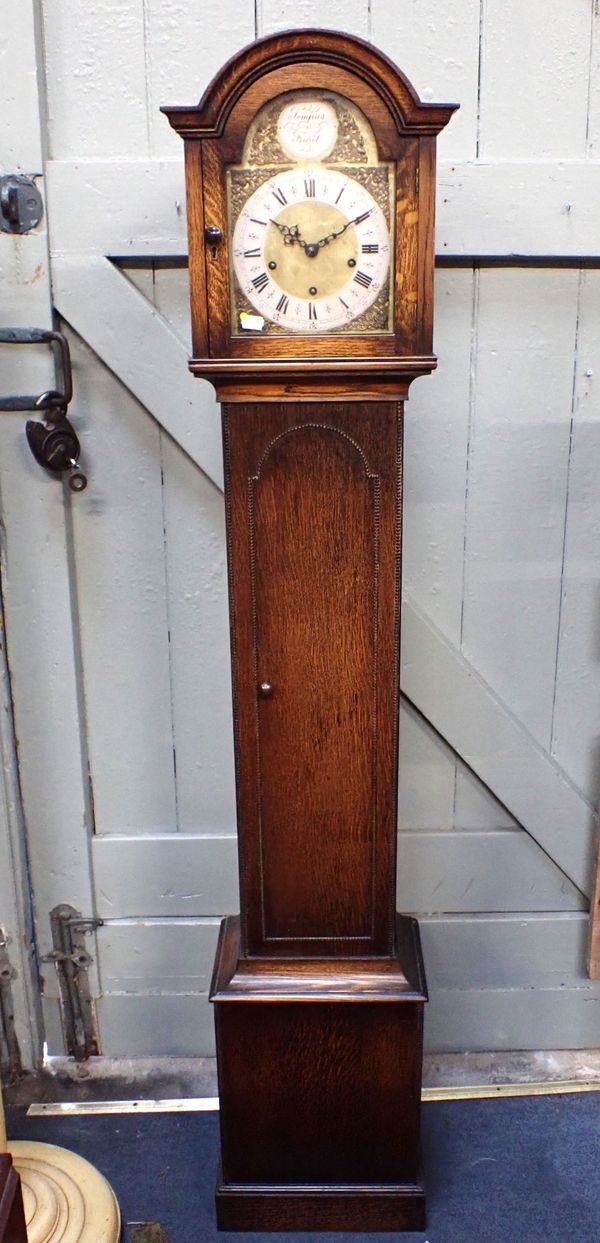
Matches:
[[216, 1176, 425, 1233]]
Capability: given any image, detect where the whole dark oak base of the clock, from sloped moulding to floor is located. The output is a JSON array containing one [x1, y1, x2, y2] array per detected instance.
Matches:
[[211, 916, 426, 1232]]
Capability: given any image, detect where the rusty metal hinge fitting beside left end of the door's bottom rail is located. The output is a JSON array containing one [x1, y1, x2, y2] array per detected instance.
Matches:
[[41, 902, 102, 1062]]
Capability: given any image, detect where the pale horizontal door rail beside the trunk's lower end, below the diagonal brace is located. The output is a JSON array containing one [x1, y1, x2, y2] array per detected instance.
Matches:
[[93, 829, 585, 919]]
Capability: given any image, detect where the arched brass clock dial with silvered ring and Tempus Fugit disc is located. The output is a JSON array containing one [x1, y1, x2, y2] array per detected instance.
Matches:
[[227, 91, 394, 336]]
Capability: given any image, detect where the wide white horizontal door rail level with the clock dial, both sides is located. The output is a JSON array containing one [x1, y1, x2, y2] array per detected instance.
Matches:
[[47, 160, 600, 265]]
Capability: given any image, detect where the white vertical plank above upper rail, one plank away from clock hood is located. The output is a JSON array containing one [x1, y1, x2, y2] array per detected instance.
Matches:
[[42, 0, 149, 159]]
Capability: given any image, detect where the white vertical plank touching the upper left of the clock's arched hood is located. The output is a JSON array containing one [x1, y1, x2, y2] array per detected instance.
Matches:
[[144, 0, 255, 159]]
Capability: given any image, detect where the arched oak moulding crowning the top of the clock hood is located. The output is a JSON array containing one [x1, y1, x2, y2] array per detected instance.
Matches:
[[160, 30, 458, 138]]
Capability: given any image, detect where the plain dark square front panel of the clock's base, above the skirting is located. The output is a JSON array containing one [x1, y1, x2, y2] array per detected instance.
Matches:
[[215, 1001, 422, 1186]]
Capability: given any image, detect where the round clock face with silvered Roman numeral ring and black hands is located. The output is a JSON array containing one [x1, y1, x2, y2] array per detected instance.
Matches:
[[232, 164, 390, 333]]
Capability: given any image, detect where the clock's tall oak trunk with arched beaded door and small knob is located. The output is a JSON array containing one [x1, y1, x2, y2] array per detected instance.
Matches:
[[224, 401, 400, 956]]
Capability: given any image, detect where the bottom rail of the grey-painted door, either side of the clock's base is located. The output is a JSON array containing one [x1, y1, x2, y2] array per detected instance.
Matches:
[[92, 912, 600, 1057]]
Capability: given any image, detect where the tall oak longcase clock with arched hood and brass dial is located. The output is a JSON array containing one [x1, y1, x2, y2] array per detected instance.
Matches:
[[163, 30, 453, 1231]]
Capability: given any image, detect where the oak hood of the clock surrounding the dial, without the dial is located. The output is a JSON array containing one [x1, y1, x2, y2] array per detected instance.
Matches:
[[161, 30, 456, 400]]
